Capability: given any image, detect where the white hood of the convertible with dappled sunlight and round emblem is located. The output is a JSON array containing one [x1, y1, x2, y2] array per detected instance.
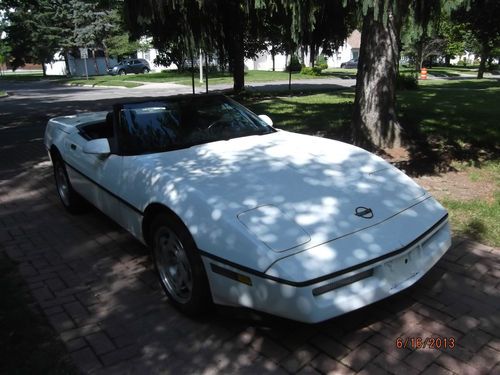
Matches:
[[137, 131, 426, 252]]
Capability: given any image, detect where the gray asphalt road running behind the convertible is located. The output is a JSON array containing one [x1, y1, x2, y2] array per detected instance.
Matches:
[[0, 78, 355, 144]]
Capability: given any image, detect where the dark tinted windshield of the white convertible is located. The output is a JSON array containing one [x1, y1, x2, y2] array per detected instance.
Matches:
[[120, 96, 275, 155]]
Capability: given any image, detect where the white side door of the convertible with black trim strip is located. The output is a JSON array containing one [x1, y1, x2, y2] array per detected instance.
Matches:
[[63, 133, 123, 223]]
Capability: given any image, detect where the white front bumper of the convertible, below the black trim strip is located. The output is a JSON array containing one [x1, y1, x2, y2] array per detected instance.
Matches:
[[203, 213, 451, 323]]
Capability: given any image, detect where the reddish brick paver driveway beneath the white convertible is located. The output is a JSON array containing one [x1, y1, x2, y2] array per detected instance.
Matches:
[[0, 83, 500, 375]]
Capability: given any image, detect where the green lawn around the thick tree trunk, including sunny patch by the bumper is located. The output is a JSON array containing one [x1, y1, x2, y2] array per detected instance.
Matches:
[[243, 80, 500, 246]]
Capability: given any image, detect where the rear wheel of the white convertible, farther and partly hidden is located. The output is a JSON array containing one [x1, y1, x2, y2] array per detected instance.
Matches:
[[52, 154, 86, 214]]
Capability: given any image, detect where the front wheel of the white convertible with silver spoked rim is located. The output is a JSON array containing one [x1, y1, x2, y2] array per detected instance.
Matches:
[[150, 214, 212, 316]]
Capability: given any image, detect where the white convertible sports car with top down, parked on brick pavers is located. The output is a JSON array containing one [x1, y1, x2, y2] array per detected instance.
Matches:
[[45, 95, 451, 323]]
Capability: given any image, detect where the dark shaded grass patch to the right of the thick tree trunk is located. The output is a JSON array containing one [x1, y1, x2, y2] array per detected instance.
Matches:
[[398, 79, 500, 154]]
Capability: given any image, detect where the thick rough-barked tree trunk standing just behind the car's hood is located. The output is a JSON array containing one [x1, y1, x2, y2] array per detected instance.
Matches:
[[352, 0, 403, 149]]
